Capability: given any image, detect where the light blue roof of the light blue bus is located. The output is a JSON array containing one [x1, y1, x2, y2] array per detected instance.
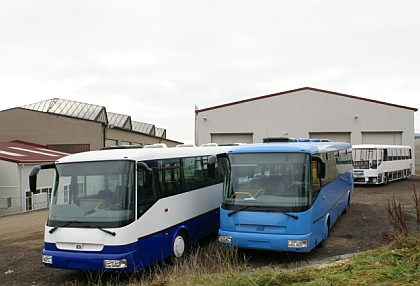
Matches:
[[227, 142, 351, 154]]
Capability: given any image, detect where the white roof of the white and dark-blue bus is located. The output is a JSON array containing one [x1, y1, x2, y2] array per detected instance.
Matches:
[[56, 146, 232, 163]]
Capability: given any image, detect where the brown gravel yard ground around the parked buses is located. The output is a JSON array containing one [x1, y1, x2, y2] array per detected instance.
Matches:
[[0, 176, 420, 285]]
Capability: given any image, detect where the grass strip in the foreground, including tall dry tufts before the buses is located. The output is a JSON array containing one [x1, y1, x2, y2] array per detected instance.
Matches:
[[74, 234, 420, 286]]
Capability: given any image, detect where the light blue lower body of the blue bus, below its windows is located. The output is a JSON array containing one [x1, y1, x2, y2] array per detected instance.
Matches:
[[219, 172, 353, 252]]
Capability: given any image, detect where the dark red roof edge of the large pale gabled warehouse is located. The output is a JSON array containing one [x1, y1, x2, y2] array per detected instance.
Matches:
[[195, 87, 418, 113]]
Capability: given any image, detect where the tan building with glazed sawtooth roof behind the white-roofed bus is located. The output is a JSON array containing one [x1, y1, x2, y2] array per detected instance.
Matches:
[[0, 98, 181, 153]]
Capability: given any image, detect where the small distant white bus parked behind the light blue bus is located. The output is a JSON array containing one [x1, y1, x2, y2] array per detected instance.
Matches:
[[353, 144, 413, 185]]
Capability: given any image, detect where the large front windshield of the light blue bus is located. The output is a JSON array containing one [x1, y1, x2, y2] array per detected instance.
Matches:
[[219, 153, 311, 212]]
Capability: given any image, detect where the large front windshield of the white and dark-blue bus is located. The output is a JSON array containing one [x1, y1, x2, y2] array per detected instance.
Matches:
[[47, 161, 135, 228]]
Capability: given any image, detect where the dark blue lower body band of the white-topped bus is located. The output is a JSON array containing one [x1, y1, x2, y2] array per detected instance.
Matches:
[[42, 209, 219, 272]]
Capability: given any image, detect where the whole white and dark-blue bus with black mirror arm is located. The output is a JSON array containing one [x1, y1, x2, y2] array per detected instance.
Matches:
[[29, 146, 228, 272]]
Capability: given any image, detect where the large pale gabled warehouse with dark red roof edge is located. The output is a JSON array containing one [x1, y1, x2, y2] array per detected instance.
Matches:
[[195, 87, 417, 172]]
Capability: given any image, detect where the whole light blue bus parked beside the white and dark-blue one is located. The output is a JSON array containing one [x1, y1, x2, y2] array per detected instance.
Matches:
[[218, 140, 353, 252]]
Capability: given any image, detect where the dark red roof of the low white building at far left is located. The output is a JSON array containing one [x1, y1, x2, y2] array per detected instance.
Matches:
[[0, 141, 70, 163]]
